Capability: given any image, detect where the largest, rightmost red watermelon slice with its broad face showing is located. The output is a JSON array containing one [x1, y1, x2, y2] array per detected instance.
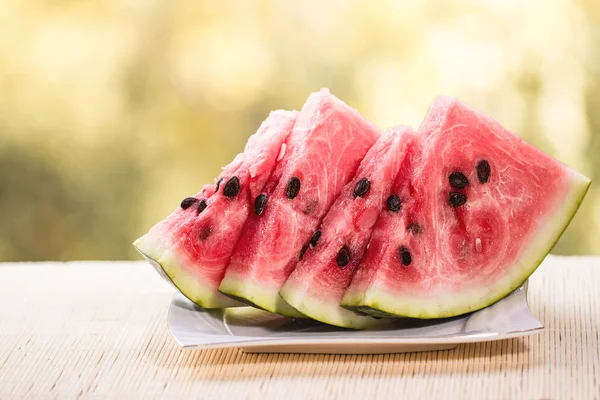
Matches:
[[341, 97, 590, 318]]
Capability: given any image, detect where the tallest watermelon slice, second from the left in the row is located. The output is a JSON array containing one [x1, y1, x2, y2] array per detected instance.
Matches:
[[219, 89, 380, 317]]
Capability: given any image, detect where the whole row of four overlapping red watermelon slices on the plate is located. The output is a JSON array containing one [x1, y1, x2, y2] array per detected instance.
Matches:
[[134, 89, 590, 329]]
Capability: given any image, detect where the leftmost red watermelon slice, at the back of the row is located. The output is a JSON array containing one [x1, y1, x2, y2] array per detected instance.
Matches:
[[134, 111, 298, 308]]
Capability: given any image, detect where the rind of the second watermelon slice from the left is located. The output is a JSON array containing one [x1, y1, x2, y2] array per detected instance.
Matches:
[[219, 275, 307, 318]]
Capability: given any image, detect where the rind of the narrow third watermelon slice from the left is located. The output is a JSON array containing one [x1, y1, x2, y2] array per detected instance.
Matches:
[[279, 284, 388, 329]]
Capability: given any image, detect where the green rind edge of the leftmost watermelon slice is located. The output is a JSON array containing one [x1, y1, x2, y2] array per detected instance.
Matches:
[[133, 234, 244, 309]]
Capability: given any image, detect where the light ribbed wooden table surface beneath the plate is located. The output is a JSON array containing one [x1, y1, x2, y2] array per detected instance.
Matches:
[[0, 257, 600, 400]]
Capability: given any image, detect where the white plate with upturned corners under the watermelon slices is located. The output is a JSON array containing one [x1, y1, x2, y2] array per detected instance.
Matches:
[[168, 283, 544, 354]]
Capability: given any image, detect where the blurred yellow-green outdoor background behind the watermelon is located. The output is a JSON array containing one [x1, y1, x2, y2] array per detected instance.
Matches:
[[0, 0, 600, 261]]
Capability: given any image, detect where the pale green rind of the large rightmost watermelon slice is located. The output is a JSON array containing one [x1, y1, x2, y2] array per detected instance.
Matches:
[[341, 171, 591, 319]]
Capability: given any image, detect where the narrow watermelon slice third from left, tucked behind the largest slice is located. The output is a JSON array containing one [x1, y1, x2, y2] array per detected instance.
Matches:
[[279, 127, 415, 329]]
